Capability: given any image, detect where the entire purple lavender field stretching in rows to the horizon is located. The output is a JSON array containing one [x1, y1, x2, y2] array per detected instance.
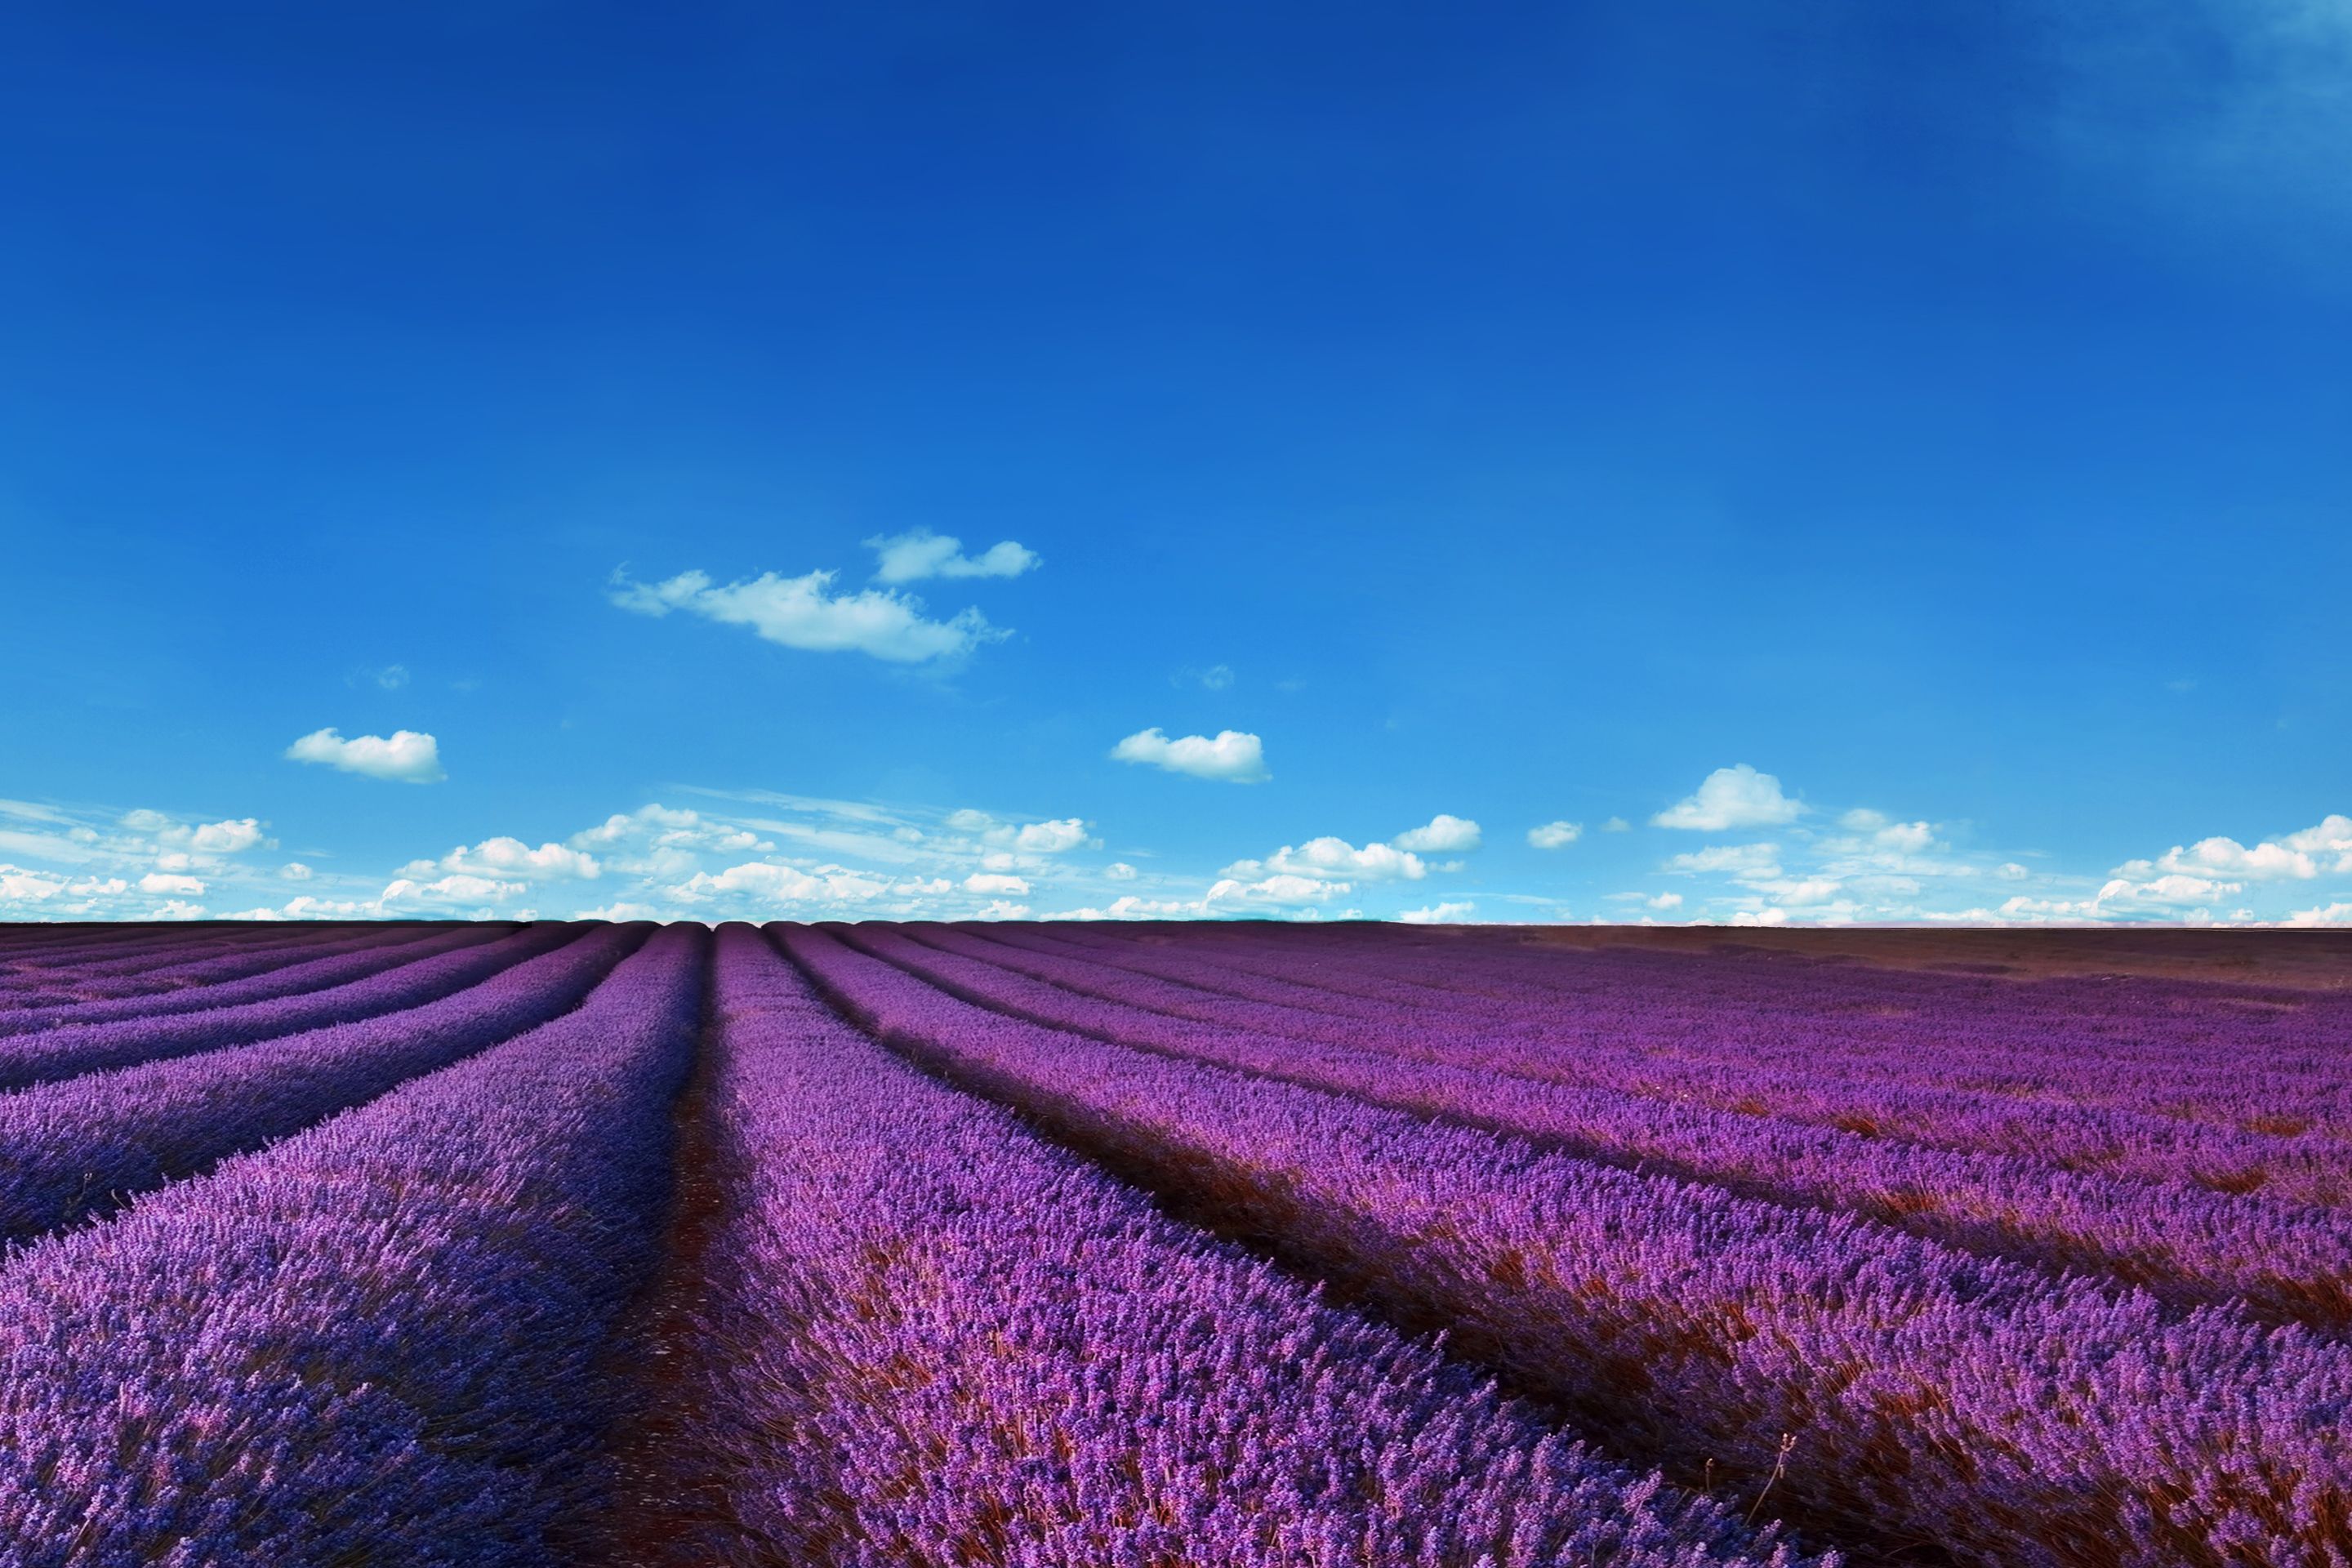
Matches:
[[0, 921, 2352, 1568]]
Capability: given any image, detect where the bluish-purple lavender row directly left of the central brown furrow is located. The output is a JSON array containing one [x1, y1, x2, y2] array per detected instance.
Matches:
[[0, 926, 708, 1568]]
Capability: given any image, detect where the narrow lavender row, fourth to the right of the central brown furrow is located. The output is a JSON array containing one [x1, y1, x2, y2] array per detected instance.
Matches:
[[1035, 931, 2352, 1206]]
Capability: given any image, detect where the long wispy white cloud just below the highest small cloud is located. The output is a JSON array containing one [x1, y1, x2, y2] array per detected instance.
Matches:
[[612, 571, 1011, 663]]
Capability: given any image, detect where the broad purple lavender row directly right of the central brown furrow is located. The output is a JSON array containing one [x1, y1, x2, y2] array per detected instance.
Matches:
[[611, 926, 1794, 1568]]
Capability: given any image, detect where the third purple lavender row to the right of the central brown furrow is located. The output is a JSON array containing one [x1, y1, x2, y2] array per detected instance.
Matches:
[[875, 926, 2352, 1330]]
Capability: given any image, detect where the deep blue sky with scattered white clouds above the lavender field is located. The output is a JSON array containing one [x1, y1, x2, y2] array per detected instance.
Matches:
[[0, 0, 2352, 921]]
